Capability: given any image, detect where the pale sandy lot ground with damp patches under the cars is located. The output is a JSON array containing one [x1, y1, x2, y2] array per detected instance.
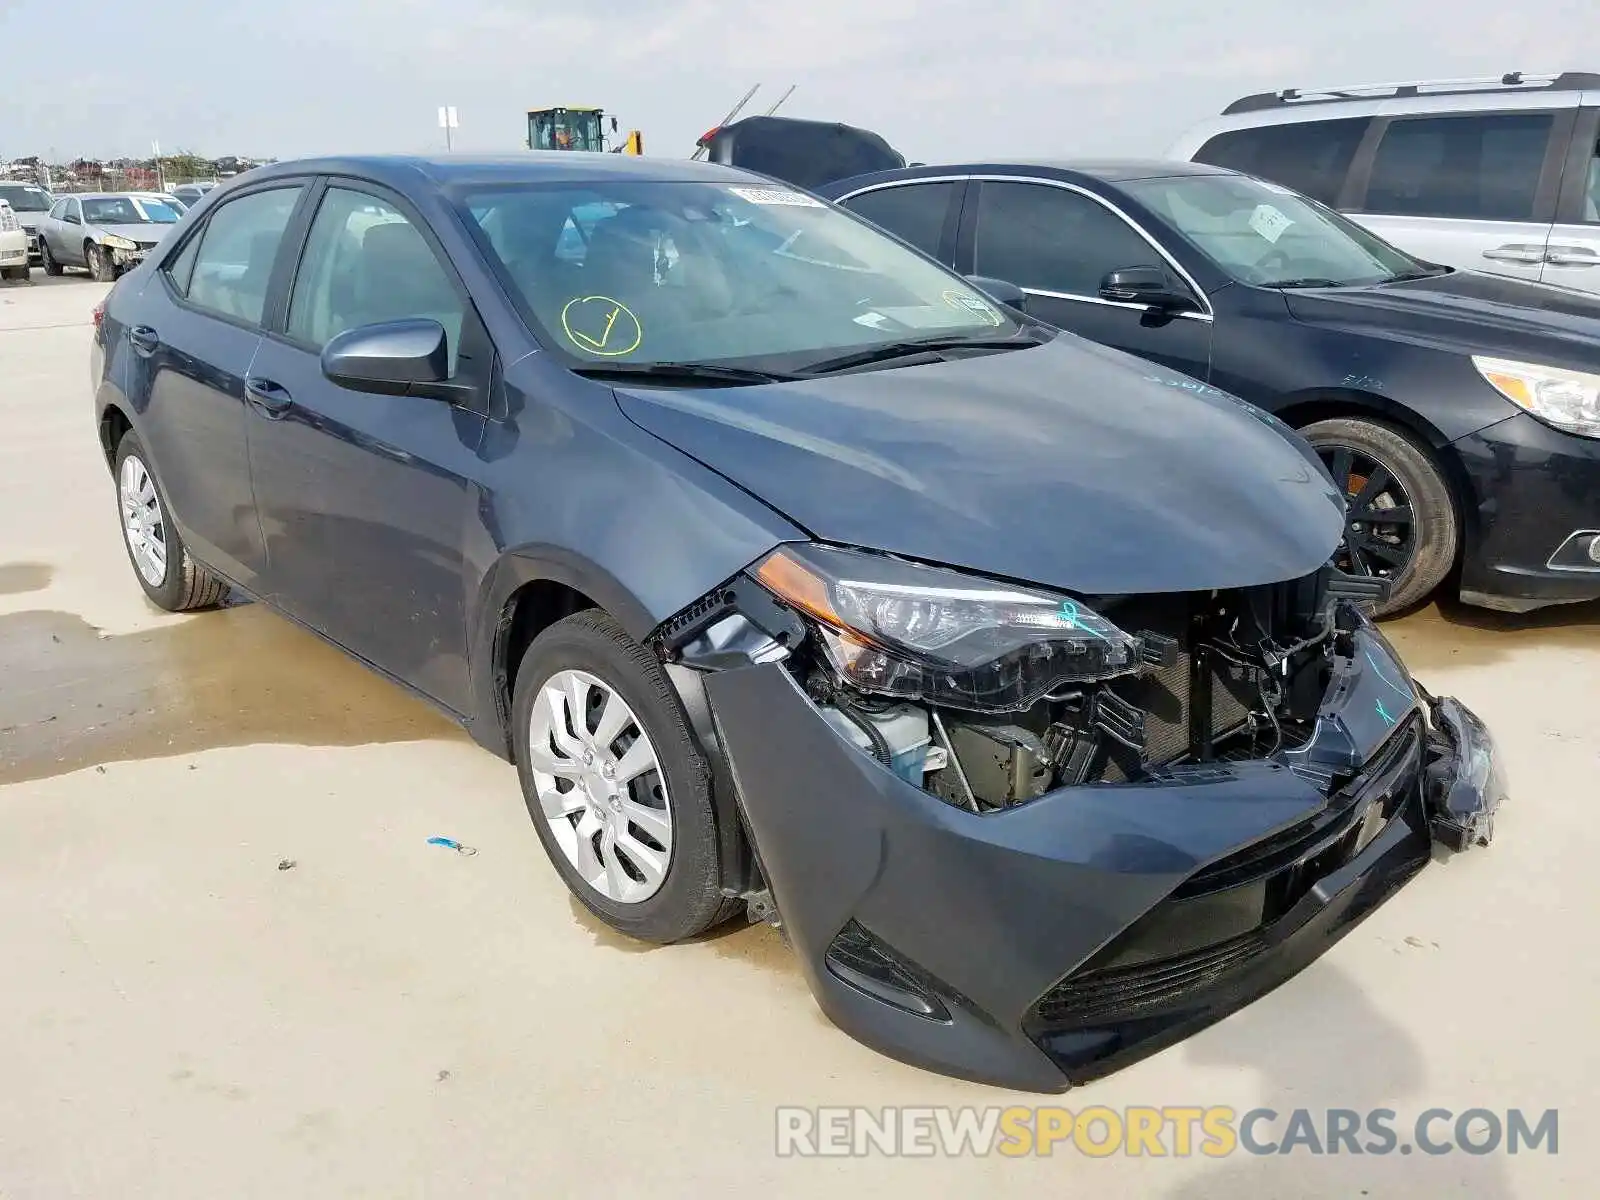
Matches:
[[0, 274, 1600, 1200]]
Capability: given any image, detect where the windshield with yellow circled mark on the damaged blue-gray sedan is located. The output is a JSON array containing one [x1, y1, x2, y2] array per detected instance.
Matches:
[[459, 181, 1018, 370]]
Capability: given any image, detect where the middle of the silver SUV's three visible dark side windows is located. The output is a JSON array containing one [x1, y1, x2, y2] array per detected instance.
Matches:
[[1365, 112, 1554, 221]]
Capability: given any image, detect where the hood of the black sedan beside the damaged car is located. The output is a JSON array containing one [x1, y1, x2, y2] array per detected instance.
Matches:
[[1285, 270, 1600, 370]]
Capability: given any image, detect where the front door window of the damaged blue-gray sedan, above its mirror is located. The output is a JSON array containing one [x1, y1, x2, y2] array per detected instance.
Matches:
[[288, 187, 466, 374]]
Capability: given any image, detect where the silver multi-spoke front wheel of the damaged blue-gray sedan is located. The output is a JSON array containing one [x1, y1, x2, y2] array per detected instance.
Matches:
[[528, 670, 672, 904]]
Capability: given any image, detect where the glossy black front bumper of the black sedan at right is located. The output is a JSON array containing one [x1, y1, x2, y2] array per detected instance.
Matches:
[[1454, 413, 1600, 613]]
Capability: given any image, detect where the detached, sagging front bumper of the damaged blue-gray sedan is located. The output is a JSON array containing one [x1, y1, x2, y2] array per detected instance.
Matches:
[[706, 634, 1504, 1091]]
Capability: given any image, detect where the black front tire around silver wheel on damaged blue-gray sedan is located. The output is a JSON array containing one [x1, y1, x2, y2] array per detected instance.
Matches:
[[512, 608, 738, 942]]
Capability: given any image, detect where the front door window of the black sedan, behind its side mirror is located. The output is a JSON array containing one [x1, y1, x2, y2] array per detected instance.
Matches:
[[974, 182, 1165, 296]]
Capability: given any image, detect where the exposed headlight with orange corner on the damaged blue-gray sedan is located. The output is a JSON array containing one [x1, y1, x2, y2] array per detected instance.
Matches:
[[755, 544, 1141, 712]]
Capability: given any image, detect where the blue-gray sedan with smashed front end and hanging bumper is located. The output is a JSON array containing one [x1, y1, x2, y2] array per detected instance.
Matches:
[[91, 155, 1504, 1090]]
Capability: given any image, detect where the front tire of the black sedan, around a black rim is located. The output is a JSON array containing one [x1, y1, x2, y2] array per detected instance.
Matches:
[[1301, 418, 1459, 616]]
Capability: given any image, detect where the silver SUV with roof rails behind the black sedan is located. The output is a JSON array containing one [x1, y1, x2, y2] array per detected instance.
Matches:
[[1168, 70, 1600, 293]]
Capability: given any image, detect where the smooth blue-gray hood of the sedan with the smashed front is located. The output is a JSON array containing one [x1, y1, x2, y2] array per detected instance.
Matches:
[[618, 336, 1344, 594]]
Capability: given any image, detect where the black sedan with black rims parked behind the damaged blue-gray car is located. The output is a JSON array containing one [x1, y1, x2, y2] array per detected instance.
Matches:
[[821, 162, 1600, 613]]
